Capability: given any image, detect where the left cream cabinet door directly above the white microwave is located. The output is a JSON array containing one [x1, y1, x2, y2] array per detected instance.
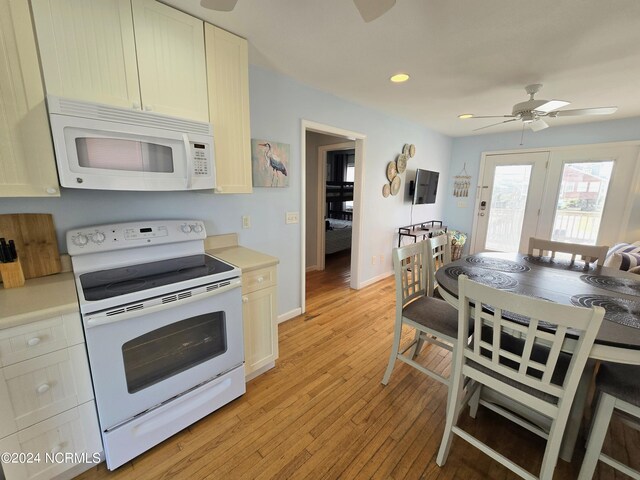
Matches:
[[32, 0, 140, 108]]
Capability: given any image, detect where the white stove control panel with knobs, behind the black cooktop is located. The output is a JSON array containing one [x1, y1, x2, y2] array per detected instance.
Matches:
[[67, 220, 207, 255]]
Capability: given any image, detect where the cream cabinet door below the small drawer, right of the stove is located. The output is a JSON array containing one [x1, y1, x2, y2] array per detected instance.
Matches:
[[242, 287, 278, 375]]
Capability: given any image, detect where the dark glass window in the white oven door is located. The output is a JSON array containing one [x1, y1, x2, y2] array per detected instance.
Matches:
[[122, 312, 227, 393]]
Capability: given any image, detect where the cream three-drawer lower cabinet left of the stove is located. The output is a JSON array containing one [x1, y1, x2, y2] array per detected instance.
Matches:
[[0, 313, 102, 480]]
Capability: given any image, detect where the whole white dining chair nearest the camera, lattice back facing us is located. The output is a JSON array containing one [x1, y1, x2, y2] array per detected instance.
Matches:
[[436, 275, 604, 480]]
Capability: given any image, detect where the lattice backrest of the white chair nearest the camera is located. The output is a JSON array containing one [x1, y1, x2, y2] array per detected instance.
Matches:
[[454, 275, 604, 418]]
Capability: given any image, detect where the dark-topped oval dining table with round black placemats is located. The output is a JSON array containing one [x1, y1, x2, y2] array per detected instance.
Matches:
[[435, 252, 640, 461]]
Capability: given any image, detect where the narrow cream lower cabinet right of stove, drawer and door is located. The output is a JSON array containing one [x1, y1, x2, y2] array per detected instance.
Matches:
[[242, 266, 278, 379]]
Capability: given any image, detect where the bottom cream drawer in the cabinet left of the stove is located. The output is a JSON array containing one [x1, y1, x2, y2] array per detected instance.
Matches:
[[0, 401, 102, 480]]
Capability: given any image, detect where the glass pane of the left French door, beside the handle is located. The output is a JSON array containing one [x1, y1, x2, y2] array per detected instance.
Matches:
[[488, 165, 532, 252]]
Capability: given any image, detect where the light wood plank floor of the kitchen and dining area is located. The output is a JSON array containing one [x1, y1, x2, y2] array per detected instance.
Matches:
[[79, 256, 640, 480]]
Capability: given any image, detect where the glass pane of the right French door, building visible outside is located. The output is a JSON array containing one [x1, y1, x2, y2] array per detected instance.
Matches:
[[551, 161, 613, 245]]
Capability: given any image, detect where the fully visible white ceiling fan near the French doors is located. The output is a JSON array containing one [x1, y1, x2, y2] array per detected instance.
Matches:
[[458, 83, 618, 132]]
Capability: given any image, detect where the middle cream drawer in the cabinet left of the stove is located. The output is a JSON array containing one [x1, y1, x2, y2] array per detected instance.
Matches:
[[0, 344, 93, 438]]
